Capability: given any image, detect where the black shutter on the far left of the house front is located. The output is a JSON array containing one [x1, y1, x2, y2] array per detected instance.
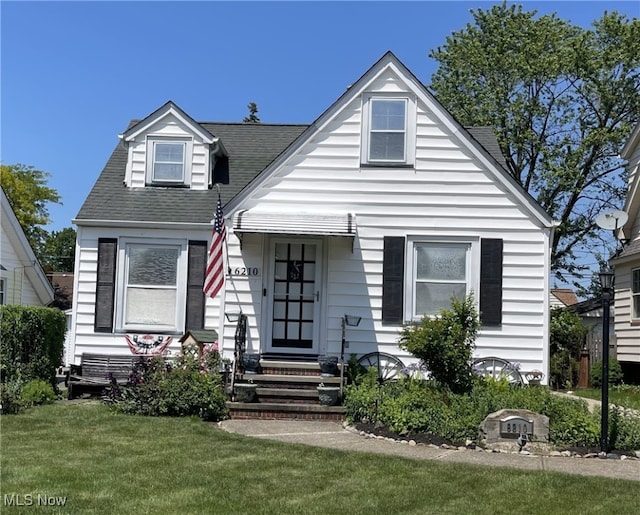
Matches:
[[93, 238, 118, 333]]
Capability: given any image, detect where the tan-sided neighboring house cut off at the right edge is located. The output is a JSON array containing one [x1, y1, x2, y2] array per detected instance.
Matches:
[[610, 119, 640, 381]]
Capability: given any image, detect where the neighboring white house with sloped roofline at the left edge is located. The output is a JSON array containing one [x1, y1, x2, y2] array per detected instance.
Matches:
[[0, 188, 54, 306]]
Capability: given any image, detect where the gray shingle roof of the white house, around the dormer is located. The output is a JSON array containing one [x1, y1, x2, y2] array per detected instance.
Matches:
[[76, 121, 505, 225]]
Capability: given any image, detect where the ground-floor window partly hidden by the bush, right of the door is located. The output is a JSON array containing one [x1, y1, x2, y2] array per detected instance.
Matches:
[[408, 241, 471, 319]]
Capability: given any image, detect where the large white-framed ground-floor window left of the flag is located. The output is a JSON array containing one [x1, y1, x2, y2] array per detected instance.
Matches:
[[118, 242, 186, 332]]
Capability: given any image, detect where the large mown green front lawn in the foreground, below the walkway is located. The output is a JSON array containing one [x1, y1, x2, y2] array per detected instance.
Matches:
[[0, 403, 640, 515]]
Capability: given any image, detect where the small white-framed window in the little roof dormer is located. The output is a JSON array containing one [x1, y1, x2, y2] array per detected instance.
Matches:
[[147, 137, 193, 186]]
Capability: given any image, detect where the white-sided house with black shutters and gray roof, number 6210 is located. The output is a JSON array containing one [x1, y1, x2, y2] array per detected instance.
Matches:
[[72, 52, 555, 377]]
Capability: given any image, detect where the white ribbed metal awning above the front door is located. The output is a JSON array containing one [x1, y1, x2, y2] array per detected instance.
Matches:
[[233, 209, 356, 238]]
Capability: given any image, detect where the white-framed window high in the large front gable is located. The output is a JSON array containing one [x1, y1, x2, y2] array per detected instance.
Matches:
[[362, 95, 415, 166]]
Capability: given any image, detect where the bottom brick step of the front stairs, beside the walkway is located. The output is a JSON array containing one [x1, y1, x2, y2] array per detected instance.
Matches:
[[227, 402, 346, 421]]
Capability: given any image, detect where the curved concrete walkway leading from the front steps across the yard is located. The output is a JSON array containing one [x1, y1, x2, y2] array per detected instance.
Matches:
[[219, 420, 640, 481]]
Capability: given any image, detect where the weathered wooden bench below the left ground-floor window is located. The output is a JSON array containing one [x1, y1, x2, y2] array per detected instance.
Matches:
[[66, 353, 140, 399]]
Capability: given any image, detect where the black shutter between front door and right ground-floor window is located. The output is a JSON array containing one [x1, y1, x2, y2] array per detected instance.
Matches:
[[382, 236, 405, 324]]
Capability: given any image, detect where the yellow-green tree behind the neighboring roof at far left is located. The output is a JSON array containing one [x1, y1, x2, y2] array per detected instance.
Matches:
[[0, 164, 61, 258]]
